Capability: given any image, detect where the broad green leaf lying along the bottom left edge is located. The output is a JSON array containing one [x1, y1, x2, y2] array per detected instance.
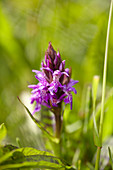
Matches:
[[0, 147, 73, 170]]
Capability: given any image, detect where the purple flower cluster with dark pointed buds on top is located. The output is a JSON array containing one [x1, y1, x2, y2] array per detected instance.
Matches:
[[28, 42, 78, 114]]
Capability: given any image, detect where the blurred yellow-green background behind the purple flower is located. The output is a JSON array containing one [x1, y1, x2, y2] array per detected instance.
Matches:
[[0, 0, 113, 167]]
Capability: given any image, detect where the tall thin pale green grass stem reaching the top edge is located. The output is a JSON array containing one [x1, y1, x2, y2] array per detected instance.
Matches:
[[95, 0, 113, 170]]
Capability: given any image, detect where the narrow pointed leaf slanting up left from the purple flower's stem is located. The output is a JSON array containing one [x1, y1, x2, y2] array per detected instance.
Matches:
[[18, 97, 59, 143]]
